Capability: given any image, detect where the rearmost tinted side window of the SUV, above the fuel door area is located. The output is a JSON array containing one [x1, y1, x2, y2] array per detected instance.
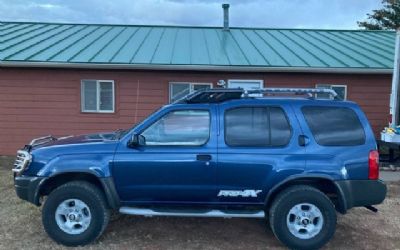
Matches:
[[302, 106, 365, 146]]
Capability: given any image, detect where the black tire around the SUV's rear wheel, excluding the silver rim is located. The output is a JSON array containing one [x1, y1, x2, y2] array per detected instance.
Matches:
[[269, 185, 337, 249]]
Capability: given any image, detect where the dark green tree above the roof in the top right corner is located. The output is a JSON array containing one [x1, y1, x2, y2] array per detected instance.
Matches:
[[357, 0, 400, 30]]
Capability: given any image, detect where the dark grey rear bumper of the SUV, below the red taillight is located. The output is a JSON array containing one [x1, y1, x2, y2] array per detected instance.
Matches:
[[335, 180, 387, 211]]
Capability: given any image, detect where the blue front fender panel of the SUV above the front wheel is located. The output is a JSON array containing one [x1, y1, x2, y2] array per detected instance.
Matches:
[[37, 154, 113, 178]]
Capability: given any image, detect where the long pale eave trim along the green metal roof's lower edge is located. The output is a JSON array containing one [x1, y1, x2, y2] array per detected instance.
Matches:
[[0, 61, 393, 74]]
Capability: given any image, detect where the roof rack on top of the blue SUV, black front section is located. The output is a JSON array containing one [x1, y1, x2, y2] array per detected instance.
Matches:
[[175, 88, 337, 103]]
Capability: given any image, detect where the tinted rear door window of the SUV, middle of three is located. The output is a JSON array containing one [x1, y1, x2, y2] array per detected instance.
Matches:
[[224, 107, 291, 147]]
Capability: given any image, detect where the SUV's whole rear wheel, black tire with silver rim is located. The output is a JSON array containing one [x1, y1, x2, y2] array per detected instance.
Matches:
[[269, 186, 336, 249]]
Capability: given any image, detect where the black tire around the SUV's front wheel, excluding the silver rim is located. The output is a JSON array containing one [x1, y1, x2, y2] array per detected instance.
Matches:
[[42, 181, 110, 246]]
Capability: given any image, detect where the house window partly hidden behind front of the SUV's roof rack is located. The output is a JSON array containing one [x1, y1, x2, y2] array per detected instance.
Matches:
[[169, 82, 212, 103]]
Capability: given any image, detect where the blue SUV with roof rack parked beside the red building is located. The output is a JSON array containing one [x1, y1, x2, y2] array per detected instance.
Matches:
[[13, 88, 386, 249]]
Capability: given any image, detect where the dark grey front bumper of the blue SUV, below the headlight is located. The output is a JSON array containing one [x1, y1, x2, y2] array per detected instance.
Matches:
[[14, 175, 46, 206]]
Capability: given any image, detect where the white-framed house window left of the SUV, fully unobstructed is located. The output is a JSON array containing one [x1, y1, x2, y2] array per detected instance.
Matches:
[[81, 80, 115, 113]]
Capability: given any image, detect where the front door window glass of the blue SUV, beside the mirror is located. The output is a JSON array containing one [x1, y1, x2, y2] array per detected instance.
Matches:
[[142, 110, 210, 146]]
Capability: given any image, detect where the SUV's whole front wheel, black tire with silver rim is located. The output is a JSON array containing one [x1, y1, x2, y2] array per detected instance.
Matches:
[[42, 181, 110, 246]]
